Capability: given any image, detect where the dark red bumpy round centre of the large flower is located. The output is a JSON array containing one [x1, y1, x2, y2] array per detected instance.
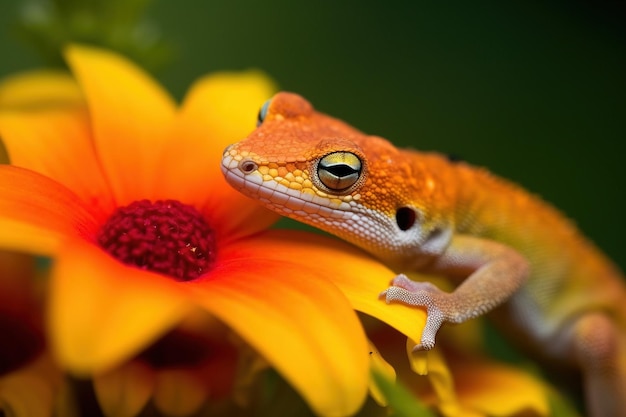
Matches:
[[98, 200, 216, 281]]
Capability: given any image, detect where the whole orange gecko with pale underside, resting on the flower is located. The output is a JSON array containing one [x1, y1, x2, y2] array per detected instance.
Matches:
[[221, 92, 626, 417]]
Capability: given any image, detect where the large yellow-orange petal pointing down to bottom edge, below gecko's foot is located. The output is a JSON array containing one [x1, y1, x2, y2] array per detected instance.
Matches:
[[187, 250, 369, 416]]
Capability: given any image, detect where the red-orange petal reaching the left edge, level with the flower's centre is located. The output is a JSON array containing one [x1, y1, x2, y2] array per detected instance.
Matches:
[[0, 165, 98, 254]]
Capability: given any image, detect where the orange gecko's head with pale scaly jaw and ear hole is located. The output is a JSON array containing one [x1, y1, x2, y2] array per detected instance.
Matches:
[[222, 93, 450, 265]]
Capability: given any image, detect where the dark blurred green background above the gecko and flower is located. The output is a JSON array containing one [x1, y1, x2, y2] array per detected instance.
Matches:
[[0, 0, 626, 269]]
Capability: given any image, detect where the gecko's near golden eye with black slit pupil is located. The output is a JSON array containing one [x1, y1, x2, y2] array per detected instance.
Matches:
[[317, 152, 362, 191]]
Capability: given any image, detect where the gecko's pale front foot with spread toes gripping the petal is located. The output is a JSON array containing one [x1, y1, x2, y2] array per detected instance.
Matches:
[[380, 274, 453, 351]]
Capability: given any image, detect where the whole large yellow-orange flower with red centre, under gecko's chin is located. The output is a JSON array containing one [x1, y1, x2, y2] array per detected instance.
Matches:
[[0, 46, 424, 416]]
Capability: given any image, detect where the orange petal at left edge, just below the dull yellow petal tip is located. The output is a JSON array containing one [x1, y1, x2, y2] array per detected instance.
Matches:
[[0, 107, 113, 216]]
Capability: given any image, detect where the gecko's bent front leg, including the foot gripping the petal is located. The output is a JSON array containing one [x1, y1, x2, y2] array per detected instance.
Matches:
[[381, 235, 529, 350]]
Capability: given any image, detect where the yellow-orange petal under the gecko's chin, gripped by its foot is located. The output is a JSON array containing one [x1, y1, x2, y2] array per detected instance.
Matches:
[[229, 230, 426, 340]]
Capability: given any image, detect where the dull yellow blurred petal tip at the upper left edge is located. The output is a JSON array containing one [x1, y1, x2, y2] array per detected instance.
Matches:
[[0, 70, 84, 110]]
